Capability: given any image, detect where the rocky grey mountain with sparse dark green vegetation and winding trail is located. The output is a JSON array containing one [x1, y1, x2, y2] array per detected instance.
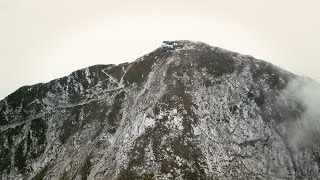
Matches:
[[0, 41, 320, 180]]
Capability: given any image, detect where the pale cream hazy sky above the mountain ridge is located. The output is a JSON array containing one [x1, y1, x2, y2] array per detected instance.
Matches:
[[0, 0, 320, 99]]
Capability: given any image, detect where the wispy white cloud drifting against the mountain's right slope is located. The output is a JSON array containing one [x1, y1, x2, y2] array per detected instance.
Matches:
[[283, 78, 320, 147]]
